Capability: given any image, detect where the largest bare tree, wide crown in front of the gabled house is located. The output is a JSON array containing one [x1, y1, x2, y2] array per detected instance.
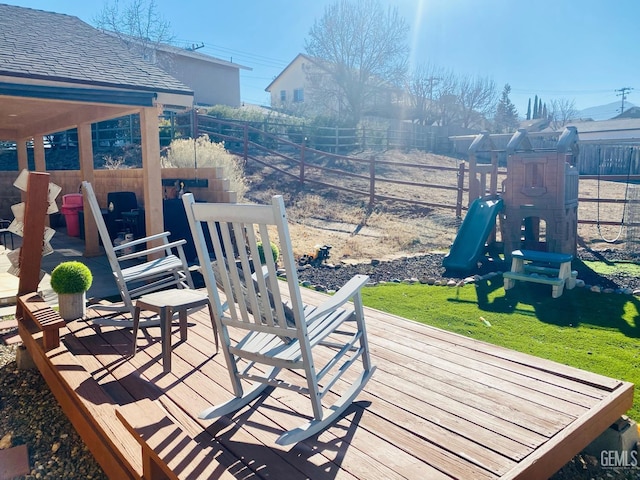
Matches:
[[305, 0, 409, 124]]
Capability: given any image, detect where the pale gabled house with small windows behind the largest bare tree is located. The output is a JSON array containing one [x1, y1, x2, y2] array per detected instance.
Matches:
[[265, 53, 409, 118]]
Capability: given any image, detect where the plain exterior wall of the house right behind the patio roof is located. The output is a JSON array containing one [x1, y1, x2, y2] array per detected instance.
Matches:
[[156, 50, 240, 107]]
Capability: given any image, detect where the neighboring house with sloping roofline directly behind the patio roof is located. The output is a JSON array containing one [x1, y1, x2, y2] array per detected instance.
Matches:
[[105, 32, 251, 108]]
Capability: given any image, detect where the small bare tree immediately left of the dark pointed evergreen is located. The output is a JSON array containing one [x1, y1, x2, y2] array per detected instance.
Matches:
[[456, 76, 497, 128]]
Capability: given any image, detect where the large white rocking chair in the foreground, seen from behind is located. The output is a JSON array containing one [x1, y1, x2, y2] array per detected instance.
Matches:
[[183, 194, 375, 445]]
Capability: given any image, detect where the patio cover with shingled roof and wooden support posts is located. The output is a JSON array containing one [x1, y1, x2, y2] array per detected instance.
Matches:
[[0, 4, 193, 255]]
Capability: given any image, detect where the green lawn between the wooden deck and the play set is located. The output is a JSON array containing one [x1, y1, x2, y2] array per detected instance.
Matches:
[[363, 282, 640, 420]]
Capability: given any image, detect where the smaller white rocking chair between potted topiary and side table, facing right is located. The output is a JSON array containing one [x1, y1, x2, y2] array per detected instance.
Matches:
[[82, 181, 194, 327]]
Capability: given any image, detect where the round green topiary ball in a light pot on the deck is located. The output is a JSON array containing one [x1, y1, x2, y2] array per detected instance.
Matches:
[[51, 261, 93, 320]]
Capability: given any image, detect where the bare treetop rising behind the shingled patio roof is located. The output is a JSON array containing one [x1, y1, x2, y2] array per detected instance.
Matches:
[[93, 0, 174, 60]]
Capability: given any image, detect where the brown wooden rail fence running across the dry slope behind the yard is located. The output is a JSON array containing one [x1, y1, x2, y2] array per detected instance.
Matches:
[[198, 117, 640, 227]]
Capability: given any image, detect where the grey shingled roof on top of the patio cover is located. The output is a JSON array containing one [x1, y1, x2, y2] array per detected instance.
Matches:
[[0, 4, 193, 95]]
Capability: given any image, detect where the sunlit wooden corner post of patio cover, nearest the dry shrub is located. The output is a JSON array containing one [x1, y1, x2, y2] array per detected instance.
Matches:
[[140, 107, 164, 259]]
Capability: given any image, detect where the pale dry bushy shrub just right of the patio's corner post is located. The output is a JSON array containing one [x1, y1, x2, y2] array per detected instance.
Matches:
[[161, 135, 247, 201]]
